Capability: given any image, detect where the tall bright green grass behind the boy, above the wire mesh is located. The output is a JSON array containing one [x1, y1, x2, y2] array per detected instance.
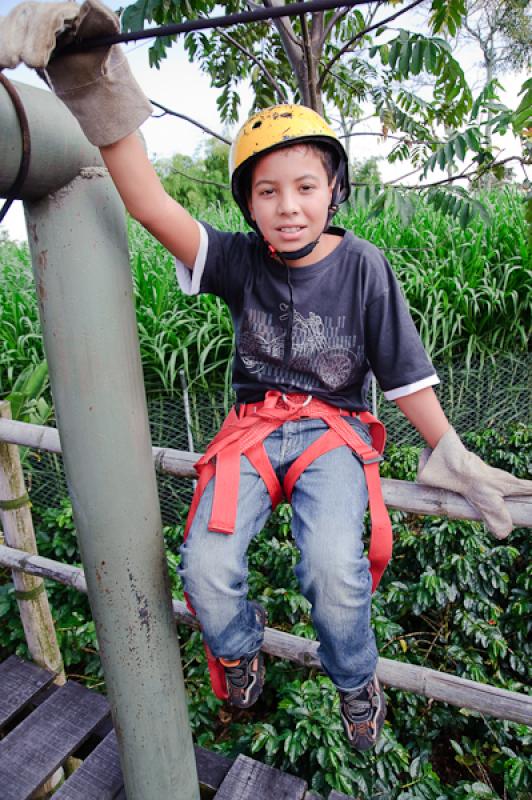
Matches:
[[0, 190, 531, 396]]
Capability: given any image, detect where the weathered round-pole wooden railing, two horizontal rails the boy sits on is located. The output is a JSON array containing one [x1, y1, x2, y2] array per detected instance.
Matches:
[[0, 419, 532, 725]]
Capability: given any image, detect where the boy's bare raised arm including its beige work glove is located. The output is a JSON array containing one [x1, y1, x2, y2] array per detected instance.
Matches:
[[0, 0, 200, 269]]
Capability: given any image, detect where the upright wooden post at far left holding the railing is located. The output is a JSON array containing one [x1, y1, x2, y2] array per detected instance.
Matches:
[[0, 401, 66, 800]]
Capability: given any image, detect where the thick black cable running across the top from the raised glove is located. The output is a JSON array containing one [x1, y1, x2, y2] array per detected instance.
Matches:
[[57, 0, 378, 56]]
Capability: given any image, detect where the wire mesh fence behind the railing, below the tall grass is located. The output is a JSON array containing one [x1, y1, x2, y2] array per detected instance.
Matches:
[[24, 353, 532, 525]]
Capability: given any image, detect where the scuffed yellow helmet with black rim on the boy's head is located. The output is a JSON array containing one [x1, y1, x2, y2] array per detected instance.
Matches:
[[229, 104, 349, 227]]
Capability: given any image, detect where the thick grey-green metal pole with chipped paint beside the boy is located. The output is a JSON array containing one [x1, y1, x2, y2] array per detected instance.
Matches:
[[0, 79, 199, 800]]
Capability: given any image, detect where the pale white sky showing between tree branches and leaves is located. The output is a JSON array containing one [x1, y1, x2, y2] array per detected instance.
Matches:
[[0, 0, 525, 240]]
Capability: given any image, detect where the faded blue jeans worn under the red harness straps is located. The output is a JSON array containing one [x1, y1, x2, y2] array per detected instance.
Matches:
[[179, 417, 377, 690]]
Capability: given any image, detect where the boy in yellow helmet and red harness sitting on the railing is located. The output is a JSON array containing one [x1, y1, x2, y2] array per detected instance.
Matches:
[[0, 0, 532, 750]]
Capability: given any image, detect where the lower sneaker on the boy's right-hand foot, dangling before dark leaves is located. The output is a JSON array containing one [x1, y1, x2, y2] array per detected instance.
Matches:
[[338, 675, 386, 750]]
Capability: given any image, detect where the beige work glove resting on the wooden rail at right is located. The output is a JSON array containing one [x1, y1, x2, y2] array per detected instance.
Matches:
[[417, 428, 532, 539]]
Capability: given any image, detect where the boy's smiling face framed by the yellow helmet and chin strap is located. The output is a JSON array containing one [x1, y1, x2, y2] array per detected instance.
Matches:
[[249, 145, 332, 266]]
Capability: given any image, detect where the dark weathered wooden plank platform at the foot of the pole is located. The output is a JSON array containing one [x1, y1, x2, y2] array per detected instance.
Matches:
[[0, 656, 355, 800]]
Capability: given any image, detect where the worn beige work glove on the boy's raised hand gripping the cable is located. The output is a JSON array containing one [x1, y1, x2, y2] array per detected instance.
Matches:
[[0, 0, 152, 147]]
